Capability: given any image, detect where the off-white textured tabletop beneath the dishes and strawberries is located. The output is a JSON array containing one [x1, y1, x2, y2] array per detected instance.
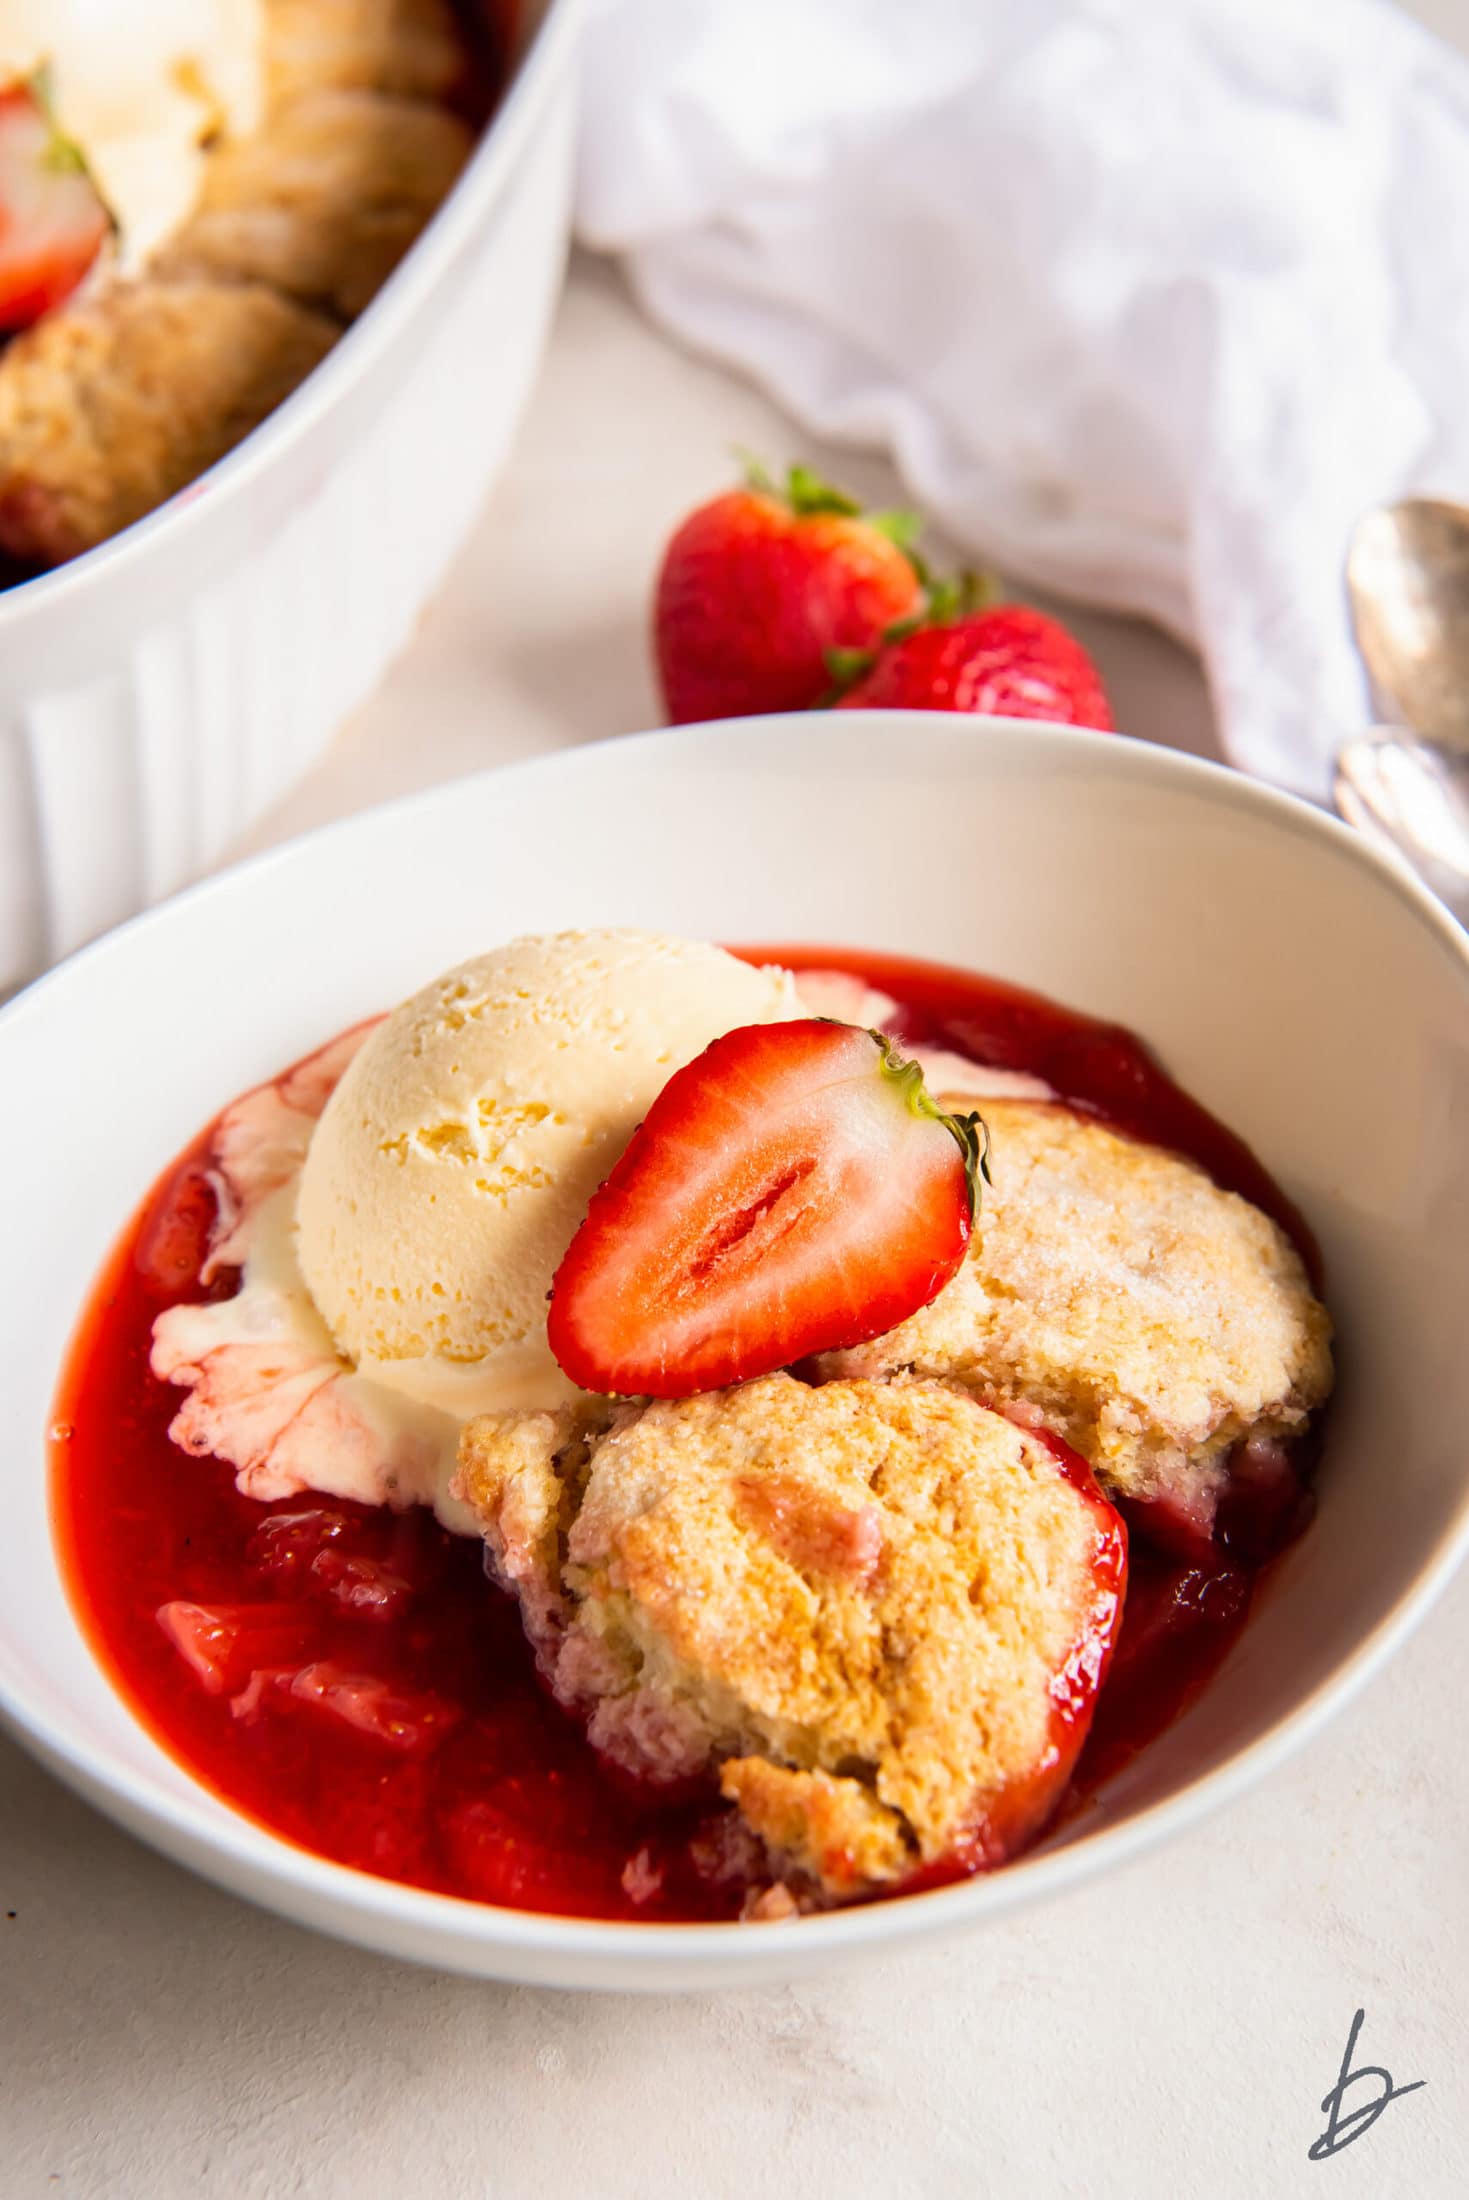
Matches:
[[0, 232, 1469, 2200]]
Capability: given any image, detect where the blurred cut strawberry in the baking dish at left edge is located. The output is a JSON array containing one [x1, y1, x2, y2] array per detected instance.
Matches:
[[0, 70, 112, 330]]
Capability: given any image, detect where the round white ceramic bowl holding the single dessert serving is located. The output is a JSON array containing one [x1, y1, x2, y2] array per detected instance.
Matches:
[[0, 713, 1469, 1987]]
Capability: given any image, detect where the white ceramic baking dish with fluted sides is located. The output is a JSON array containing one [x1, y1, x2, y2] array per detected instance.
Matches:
[[0, 0, 578, 994]]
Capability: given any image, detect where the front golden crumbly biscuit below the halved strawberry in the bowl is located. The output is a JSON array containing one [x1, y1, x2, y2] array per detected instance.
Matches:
[[457, 1375, 1124, 1899]]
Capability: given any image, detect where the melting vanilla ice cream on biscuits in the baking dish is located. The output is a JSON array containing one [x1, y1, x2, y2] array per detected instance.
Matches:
[[0, 0, 264, 266]]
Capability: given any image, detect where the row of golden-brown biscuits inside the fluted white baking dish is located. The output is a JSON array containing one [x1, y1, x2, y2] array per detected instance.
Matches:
[[0, 0, 473, 565]]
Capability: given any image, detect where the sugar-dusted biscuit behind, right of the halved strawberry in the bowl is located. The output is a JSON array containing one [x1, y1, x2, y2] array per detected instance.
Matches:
[[820, 1102, 1330, 1533]]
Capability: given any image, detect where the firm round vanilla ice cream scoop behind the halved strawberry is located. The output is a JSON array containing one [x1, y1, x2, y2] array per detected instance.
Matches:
[[297, 931, 803, 1417]]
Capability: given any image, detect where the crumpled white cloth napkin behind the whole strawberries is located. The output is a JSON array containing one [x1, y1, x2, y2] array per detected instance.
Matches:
[[578, 0, 1469, 794]]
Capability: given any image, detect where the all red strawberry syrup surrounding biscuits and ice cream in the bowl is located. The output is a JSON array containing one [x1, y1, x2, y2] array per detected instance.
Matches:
[[51, 948, 1311, 1923]]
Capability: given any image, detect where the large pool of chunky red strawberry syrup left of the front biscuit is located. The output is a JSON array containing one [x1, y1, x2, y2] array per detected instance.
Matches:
[[51, 1133, 743, 1918]]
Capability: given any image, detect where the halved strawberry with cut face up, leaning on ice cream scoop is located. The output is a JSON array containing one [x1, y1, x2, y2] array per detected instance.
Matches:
[[548, 1019, 985, 1397]]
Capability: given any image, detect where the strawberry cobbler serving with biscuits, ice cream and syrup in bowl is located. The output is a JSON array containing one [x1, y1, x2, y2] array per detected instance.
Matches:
[[53, 931, 1333, 1925]]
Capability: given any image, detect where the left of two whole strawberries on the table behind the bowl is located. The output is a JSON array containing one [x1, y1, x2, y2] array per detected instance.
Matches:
[[653, 466, 924, 726]]
